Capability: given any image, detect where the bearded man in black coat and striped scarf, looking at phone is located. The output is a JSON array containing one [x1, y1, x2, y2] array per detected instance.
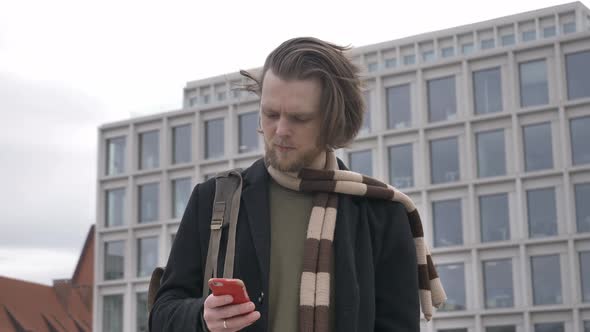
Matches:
[[150, 38, 444, 331]]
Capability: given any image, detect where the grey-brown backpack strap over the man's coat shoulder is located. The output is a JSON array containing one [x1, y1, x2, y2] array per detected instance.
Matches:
[[203, 169, 242, 297]]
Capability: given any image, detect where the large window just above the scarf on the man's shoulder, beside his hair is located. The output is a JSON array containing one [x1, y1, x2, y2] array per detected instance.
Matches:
[[389, 143, 414, 188]]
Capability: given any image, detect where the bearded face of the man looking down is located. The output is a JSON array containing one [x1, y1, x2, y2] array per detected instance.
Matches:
[[260, 69, 322, 172]]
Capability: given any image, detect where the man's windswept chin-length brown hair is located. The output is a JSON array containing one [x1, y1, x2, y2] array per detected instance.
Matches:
[[240, 37, 365, 149]]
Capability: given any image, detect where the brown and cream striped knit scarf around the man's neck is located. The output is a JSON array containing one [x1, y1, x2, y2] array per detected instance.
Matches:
[[267, 151, 446, 332]]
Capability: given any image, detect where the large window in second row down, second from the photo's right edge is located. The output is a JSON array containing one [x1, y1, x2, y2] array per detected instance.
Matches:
[[523, 122, 553, 172]]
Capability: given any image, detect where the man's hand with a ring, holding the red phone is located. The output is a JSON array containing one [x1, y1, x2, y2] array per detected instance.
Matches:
[[203, 294, 260, 332]]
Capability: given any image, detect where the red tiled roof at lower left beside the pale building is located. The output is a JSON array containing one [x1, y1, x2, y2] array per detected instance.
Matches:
[[0, 226, 94, 332]]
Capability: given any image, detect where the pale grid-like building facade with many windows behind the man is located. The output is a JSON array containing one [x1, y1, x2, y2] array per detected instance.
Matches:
[[93, 2, 590, 332]]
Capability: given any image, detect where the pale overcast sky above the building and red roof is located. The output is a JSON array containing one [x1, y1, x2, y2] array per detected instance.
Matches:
[[0, 0, 588, 284]]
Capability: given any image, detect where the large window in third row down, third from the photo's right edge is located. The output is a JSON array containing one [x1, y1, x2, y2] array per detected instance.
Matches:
[[479, 193, 510, 242]]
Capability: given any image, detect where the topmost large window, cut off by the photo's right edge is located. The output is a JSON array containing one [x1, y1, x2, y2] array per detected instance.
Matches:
[[565, 51, 590, 100]]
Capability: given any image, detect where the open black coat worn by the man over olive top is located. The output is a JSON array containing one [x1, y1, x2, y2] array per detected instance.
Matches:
[[150, 160, 420, 332]]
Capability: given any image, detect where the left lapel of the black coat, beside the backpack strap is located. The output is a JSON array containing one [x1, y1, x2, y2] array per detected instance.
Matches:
[[242, 159, 270, 291]]
